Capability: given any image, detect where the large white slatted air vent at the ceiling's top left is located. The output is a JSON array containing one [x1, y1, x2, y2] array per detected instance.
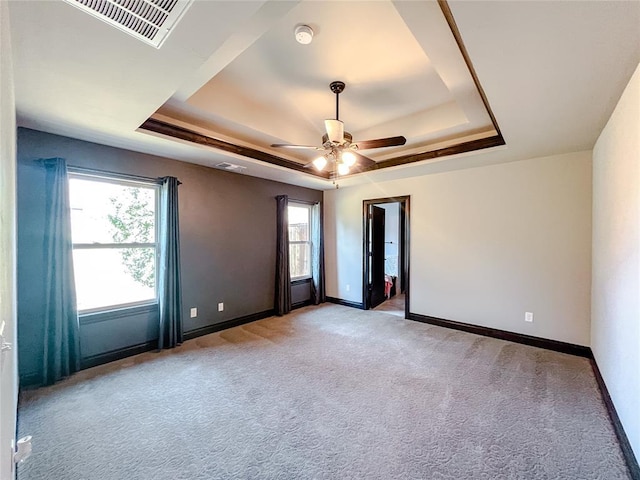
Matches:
[[64, 0, 193, 48]]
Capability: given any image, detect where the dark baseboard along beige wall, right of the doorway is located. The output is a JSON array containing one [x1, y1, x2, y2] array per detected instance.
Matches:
[[407, 313, 593, 358]]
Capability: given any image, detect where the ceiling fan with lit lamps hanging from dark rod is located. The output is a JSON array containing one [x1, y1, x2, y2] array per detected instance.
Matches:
[[271, 81, 407, 175]]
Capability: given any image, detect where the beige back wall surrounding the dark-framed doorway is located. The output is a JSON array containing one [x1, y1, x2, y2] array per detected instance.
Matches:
[[325, 152, 591, 345]]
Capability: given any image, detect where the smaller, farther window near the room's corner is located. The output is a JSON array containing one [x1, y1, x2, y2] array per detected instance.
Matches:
[[287, 202, 311, 280]]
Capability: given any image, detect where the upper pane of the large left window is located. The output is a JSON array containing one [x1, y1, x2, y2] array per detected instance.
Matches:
[[69, 177, 156, 243]]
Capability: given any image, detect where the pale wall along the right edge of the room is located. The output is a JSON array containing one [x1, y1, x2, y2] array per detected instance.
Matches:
[[591, 62, 640, 458]]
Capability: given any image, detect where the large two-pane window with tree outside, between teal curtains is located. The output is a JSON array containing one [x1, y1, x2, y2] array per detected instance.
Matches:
[[69, 173, 158, 312]]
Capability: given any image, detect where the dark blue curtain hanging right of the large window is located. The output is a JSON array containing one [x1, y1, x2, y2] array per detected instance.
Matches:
[[158, 177, 183, 349]]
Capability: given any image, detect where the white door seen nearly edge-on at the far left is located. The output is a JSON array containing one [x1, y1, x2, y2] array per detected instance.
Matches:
[[0, 1, 18, 480]]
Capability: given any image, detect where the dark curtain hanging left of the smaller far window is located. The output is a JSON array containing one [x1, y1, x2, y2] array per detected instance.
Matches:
[[275, 195, 291, 315]]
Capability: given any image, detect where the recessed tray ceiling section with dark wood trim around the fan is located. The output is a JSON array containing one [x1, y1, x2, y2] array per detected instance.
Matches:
[[142, 1, 504, 175]]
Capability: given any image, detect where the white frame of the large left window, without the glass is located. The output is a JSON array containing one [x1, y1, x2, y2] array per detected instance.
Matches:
[[68, 168, 160, 316]]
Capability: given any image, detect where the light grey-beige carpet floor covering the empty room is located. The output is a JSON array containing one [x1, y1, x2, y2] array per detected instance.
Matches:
[[18, 304, 630, 480]]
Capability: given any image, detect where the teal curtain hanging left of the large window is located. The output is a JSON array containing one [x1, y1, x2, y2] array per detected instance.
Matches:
[[41, 158, 80, 385]]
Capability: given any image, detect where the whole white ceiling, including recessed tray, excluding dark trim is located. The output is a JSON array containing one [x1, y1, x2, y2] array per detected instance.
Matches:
[[10, 0, 640, 188]]
